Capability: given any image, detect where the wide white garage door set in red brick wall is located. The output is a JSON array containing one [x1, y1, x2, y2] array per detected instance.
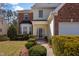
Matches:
[[59, 22, 79, 35]]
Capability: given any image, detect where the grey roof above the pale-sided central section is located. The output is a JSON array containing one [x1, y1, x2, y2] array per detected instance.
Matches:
[[32, 3, 61, 9]]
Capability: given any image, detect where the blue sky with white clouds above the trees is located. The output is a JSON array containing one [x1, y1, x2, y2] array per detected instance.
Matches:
[[4, 3, 34, 11]]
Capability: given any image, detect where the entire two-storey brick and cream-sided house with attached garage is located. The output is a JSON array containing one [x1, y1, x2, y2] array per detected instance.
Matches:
[[19, 3, 79, 38]]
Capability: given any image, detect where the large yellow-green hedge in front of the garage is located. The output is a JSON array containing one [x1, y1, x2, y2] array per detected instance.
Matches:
[[52, 36, 79, 56]]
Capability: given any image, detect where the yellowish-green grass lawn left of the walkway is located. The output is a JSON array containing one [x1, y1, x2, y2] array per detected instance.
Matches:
[[0, 41, 27, 56]]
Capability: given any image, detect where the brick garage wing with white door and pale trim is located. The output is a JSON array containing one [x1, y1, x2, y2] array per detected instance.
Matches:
[[48, 3, 79, 36]]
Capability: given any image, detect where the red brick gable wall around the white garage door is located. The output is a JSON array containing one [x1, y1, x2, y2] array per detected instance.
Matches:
[[54, 3, 79, 35]]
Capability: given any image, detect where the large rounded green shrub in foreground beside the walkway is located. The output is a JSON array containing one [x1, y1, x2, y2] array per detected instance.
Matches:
[[29, 45, 47, 56]]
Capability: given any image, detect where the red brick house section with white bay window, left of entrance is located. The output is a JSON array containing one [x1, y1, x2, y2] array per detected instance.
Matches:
[[18, 10, 32, 34]]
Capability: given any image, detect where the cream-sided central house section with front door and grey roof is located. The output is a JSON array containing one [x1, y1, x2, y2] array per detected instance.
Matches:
[[32, 3, 60, 38]]
